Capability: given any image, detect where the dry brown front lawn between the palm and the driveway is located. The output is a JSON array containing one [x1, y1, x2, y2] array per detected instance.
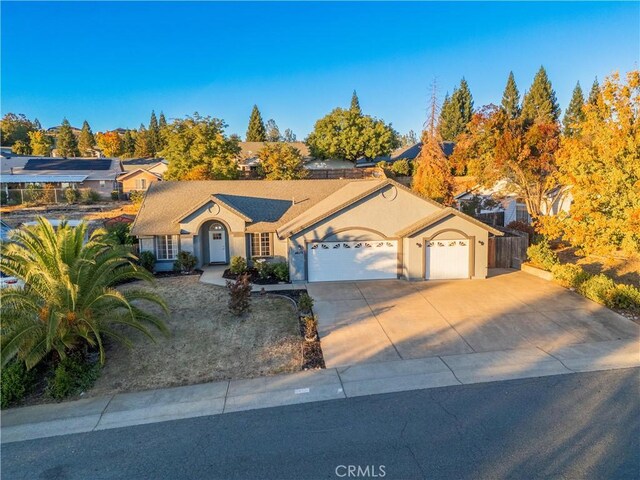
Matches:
[[88, 276, 302, 395]]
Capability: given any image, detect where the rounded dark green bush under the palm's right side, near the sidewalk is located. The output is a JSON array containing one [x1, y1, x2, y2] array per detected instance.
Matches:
[[47, 353, 100, 399]]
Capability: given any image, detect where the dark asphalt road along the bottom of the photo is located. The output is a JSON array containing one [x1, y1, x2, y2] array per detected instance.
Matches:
[[1, 369, 640, 480]]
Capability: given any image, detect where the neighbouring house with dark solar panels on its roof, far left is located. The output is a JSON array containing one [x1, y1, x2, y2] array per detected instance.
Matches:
[[0, 157, 122, 198]]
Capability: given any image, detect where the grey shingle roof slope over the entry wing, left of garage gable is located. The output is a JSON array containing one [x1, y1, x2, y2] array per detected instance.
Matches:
[[132, 180, 362, 235]]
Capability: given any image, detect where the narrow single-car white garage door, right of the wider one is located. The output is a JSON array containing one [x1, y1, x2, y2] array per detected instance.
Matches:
[[425, 238, 469, 280]]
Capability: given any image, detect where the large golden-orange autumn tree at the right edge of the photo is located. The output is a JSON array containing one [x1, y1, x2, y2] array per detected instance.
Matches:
[[542, 70, 640, 253]]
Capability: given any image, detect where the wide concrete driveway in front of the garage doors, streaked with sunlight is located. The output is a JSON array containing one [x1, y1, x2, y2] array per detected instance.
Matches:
[[307, 270, 640, 367]]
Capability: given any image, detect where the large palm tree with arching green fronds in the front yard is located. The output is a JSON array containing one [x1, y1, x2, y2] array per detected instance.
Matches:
[[0, 218, 168, 369]]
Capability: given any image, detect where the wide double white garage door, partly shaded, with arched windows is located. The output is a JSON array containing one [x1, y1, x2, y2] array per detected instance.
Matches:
[[307, 240, 398, 282]]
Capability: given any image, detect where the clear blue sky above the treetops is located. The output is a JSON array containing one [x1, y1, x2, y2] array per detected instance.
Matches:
[[1, 1, 640, 139]]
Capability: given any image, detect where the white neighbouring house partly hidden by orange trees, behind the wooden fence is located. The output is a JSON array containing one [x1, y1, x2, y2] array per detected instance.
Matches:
[[455, 180, 572, 227]]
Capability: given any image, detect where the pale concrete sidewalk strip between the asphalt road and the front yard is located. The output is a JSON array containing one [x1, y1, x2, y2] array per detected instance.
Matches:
[[1, 340, 640, 443]]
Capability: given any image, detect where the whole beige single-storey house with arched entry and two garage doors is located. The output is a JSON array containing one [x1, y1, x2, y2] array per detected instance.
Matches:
[[132, 179, 501, 282]]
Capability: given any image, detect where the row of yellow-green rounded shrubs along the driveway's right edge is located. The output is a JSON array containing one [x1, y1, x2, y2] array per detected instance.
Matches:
[[551, 264, 640, 311]]
